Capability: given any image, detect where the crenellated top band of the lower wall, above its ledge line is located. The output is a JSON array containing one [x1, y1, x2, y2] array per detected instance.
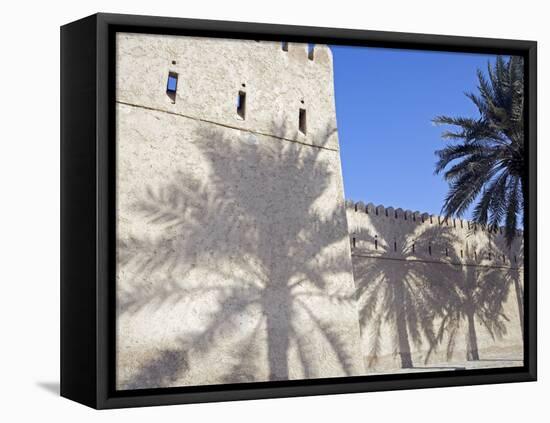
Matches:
[[346, 200, 523, 268]]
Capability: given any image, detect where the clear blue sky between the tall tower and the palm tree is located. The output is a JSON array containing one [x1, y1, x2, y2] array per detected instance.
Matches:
[[331, 46, 502, 218]]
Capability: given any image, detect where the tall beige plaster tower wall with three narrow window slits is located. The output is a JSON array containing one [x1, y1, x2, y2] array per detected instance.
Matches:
[[116, 34, 364, 389]]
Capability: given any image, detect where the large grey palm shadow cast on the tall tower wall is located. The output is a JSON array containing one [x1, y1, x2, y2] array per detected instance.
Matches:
[[117, 121, 358, 388]]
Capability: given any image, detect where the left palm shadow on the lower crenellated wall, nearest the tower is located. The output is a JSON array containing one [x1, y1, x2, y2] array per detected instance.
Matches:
[[353, 224, 458, 369]]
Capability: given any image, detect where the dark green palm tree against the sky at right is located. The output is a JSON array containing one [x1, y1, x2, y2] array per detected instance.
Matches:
[[433, 56, 526, 245]]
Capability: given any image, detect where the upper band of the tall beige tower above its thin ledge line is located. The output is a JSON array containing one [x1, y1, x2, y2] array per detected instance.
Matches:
[[117, 34, 338, 150]]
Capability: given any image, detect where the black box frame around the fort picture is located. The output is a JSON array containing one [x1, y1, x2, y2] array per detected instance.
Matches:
[[61, 13, 537, 409]]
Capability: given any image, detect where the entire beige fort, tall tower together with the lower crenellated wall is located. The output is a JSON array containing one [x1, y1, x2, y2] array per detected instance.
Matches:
[[116, 34, 522, 389]]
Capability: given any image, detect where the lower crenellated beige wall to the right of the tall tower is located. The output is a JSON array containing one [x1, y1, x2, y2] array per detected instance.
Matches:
[[347, 201, 523, 372]]
